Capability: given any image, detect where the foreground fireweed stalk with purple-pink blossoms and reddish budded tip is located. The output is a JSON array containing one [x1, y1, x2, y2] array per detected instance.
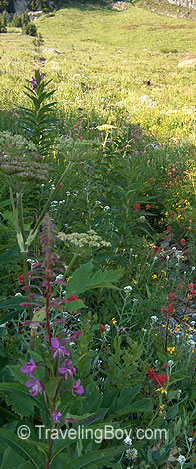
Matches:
[[21, 215, 84, 469]]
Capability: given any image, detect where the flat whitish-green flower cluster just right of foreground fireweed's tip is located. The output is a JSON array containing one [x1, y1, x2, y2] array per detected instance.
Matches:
[[58, 230, 111, 248]]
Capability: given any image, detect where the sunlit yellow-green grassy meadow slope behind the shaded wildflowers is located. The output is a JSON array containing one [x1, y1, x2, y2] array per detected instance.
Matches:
[[0, 4, 196, 142]]
